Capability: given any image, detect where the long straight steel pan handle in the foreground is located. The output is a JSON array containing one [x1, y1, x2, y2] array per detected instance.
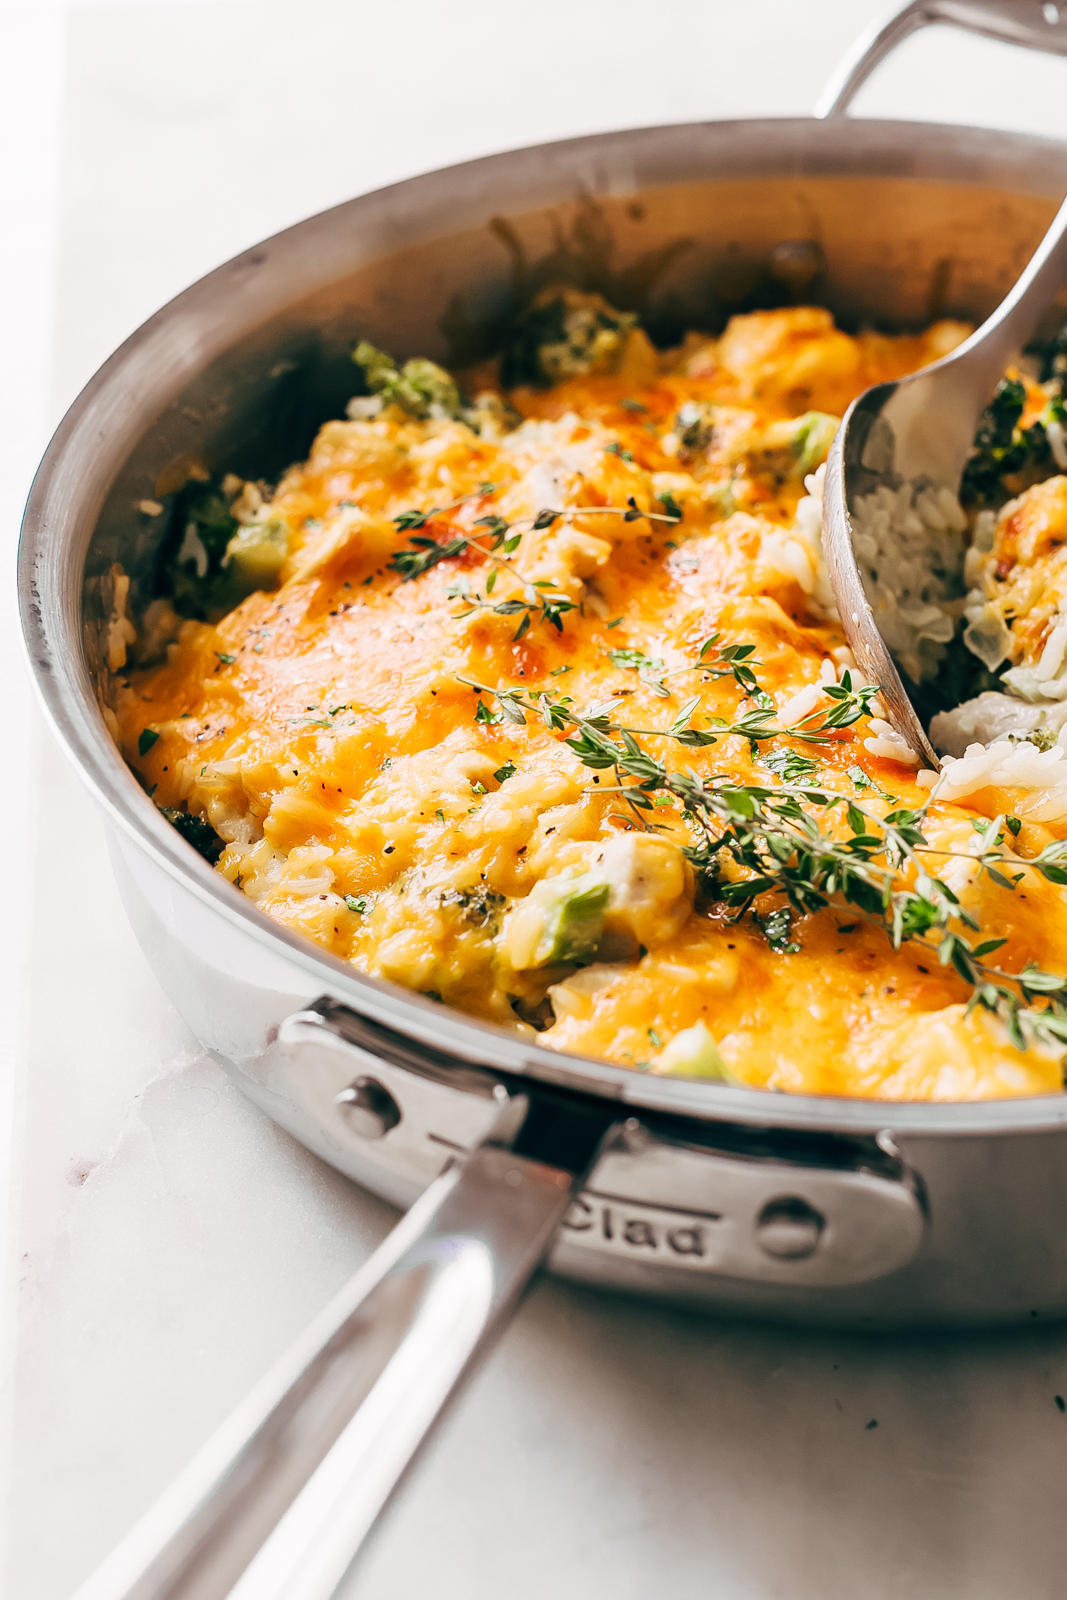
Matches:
[[75, 1090, 613, 1600]]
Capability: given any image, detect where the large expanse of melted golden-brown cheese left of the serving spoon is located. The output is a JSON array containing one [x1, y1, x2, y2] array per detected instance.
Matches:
[[117, 307, 1067, 1099]]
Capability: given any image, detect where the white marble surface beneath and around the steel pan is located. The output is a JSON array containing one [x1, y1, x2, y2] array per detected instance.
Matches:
[[10, 0, 1067, 1600]]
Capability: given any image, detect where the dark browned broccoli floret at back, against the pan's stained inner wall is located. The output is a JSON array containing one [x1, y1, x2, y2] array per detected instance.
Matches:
[[501, 283, 638, 389]]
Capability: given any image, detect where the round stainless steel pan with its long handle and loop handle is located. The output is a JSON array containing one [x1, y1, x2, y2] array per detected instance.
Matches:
[[21, 0, 1067, 1600]]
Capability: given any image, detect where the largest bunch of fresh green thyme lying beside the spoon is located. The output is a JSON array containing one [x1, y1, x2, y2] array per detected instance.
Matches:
[[461, 651, 1067, 1050]]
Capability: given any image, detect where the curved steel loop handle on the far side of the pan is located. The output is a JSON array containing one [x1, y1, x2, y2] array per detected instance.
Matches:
[[814, 0, 1067, 117]]
